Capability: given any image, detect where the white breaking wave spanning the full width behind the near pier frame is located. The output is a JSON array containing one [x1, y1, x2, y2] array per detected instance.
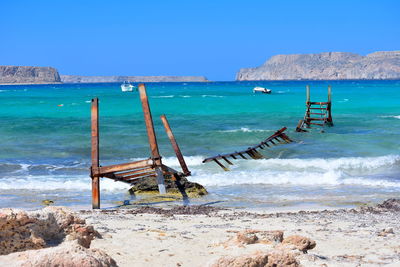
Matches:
[[0, 155, 400, 191]]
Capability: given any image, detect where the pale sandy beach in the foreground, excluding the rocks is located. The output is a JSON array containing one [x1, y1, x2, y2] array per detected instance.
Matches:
[[76, 201, 400, 266]]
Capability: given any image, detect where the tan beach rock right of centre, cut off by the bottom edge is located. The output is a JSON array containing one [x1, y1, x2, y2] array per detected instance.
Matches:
[[211, 250, 299, 267]]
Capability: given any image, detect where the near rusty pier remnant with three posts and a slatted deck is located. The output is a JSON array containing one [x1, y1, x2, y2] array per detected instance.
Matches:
[[90, 84, 190, 209]]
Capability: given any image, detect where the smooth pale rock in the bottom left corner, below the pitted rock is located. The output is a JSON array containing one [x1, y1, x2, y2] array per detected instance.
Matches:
[[0, 242, 117, 267]]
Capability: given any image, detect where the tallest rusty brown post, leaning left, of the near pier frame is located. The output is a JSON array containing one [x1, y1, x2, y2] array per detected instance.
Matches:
[[139, 83, 166, 194]]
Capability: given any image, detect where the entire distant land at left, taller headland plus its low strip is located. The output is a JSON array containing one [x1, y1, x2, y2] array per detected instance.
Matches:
[[0, 66, 208, 84]]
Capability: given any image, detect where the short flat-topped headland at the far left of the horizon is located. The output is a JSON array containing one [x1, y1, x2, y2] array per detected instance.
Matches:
[[0, 66, 61, 84]]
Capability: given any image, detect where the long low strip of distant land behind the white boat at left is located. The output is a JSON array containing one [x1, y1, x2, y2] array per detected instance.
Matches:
[[61, 75, 208, 83]]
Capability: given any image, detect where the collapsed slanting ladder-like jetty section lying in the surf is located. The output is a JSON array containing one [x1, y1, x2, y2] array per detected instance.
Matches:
[[203, 127, 293, 171]]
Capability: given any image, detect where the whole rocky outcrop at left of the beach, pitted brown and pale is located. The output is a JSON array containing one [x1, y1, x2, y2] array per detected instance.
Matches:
[[0, 207, 117, 267]]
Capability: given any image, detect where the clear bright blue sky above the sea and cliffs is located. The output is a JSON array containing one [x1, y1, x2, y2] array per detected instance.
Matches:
[[0, 0, 400, 81]]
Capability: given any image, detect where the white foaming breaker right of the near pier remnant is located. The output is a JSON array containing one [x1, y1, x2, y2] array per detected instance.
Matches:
[[191, 155, 400, 188]]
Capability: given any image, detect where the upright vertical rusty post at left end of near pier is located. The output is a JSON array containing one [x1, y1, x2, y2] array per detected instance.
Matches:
[[90, 98, 100, 209]]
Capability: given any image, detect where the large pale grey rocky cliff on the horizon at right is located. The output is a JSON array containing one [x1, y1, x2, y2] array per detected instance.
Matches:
[[236, 51, 400, 81]]
